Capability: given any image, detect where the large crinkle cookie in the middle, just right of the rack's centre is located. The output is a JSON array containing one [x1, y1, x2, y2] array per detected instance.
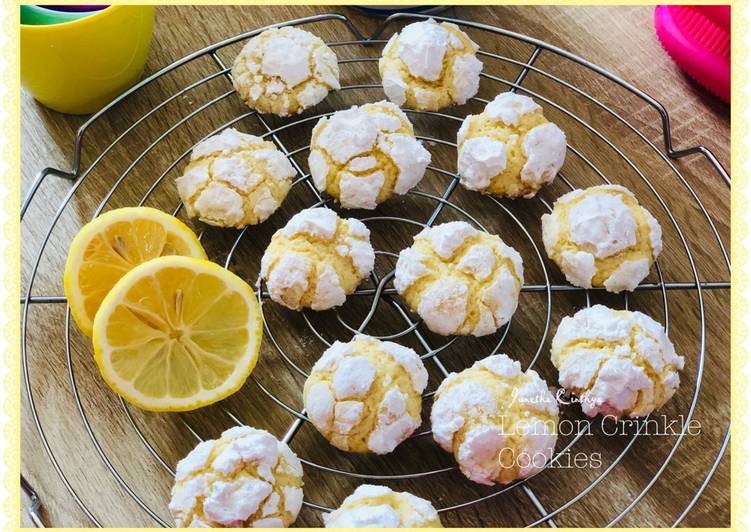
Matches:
[[394, 222, 524, 336]]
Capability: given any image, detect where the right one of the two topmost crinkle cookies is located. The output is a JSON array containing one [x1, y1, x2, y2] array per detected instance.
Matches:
[[378, 19, 482, 111]]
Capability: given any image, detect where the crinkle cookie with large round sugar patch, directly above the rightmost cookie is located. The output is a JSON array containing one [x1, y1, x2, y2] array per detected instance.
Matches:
[[542, 185, 662, 293]]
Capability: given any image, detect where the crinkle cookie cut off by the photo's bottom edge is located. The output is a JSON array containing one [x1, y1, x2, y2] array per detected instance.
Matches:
[[323, 484, 442, 528]]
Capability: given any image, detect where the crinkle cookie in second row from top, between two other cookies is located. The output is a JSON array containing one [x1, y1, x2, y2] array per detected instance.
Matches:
[[308, 102, 430, 209]]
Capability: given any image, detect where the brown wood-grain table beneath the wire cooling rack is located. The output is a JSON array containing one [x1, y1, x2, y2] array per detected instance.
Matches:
[[21, 6, 730, 527]]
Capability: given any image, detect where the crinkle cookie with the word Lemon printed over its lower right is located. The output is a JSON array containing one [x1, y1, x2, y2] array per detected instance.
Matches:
[[430, 355, 558, 485]]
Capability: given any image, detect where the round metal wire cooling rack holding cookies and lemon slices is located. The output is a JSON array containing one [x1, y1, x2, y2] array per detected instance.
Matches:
[[21, 13, 730, 527]]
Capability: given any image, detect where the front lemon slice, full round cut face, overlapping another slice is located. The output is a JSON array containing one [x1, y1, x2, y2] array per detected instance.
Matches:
[[93, 256, 262, 411]]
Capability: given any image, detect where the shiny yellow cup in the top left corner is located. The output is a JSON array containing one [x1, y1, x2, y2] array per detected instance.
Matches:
[[21, 5, 154, 114]]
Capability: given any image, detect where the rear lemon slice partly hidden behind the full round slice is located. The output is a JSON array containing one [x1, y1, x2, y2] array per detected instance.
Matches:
[[63, 207, 206, 337]]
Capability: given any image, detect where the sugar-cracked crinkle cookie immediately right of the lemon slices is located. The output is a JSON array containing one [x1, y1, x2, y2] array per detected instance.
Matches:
[[261, 207, 375, 310]]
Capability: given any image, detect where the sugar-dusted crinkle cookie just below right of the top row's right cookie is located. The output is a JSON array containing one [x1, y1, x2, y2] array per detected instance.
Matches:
[[457, 92, 566, 198]]
